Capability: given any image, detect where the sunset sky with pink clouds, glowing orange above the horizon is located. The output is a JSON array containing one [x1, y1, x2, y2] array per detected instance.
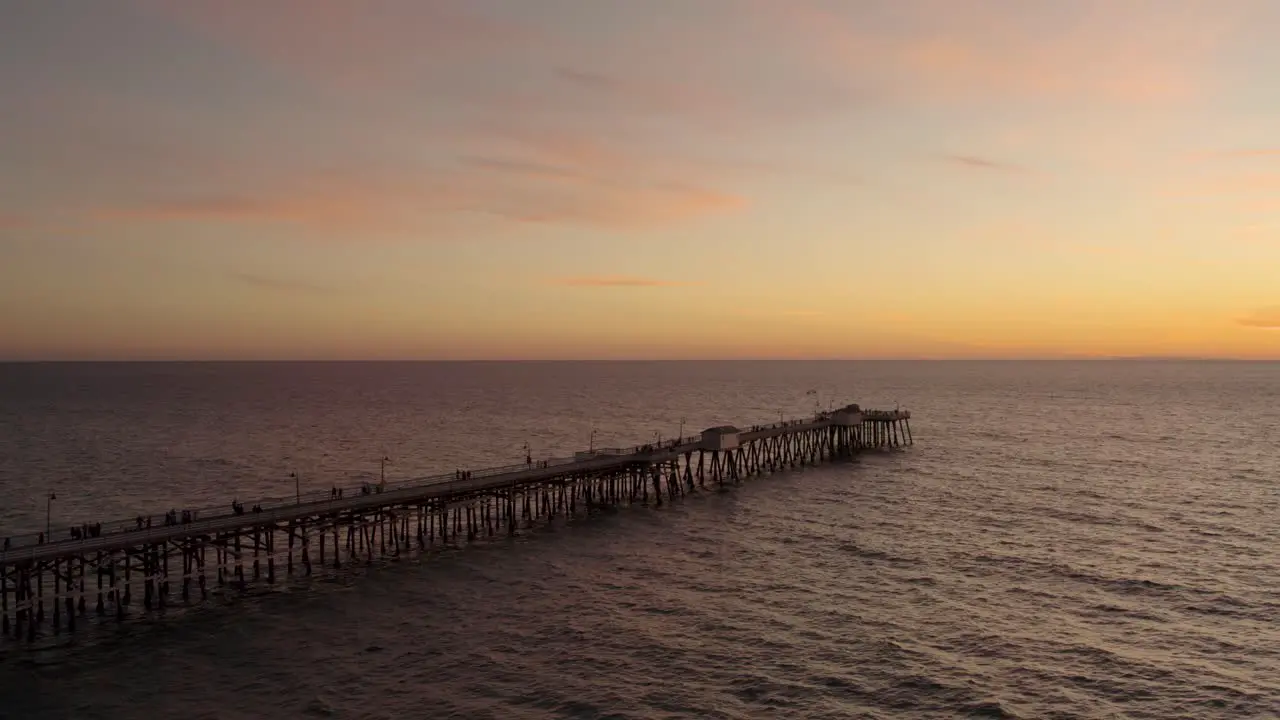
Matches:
[[0, 0, 1280, 360]]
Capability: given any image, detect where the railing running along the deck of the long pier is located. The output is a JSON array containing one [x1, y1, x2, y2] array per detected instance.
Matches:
[[3, 411, 896, 552]]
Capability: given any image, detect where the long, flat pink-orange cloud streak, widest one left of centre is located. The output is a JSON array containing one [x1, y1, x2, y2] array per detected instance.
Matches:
[[93, 155, 746, 230]]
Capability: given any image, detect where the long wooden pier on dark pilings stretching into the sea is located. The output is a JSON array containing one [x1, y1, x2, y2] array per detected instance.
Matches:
[[0, 405, 913, 642]]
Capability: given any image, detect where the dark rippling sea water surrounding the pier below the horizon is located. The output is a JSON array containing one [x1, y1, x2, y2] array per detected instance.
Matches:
[[0, 363, 1280, 720]]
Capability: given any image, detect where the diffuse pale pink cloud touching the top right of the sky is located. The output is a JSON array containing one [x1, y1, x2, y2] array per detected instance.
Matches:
[[758, 0, 1247, 104]]
